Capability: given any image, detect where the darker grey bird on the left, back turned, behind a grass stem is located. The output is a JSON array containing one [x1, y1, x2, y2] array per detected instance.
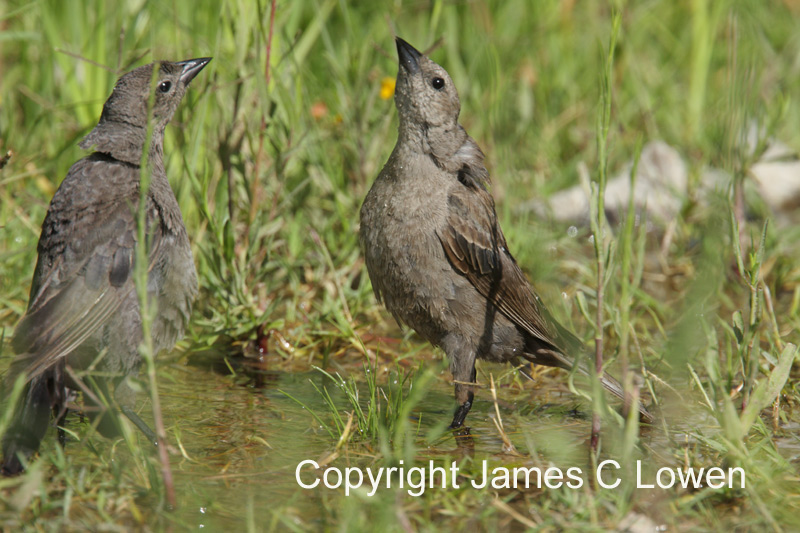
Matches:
[[2, 58, 211, 475]]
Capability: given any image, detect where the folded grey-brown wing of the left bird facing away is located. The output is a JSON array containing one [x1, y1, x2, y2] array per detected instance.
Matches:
[[12, 164, 162, 380]]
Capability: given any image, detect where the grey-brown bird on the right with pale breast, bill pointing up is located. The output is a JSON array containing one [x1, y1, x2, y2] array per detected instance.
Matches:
[[360, 38, 652, 428]]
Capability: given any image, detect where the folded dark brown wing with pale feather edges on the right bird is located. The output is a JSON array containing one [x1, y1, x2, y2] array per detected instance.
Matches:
[[439, 168, 571, 354]]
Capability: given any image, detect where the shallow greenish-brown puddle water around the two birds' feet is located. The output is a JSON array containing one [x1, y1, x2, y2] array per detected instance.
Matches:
[[155, 354, 588, 530]]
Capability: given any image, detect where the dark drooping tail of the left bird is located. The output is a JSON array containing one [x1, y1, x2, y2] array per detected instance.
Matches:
[[0, 365, 65, 476]]
